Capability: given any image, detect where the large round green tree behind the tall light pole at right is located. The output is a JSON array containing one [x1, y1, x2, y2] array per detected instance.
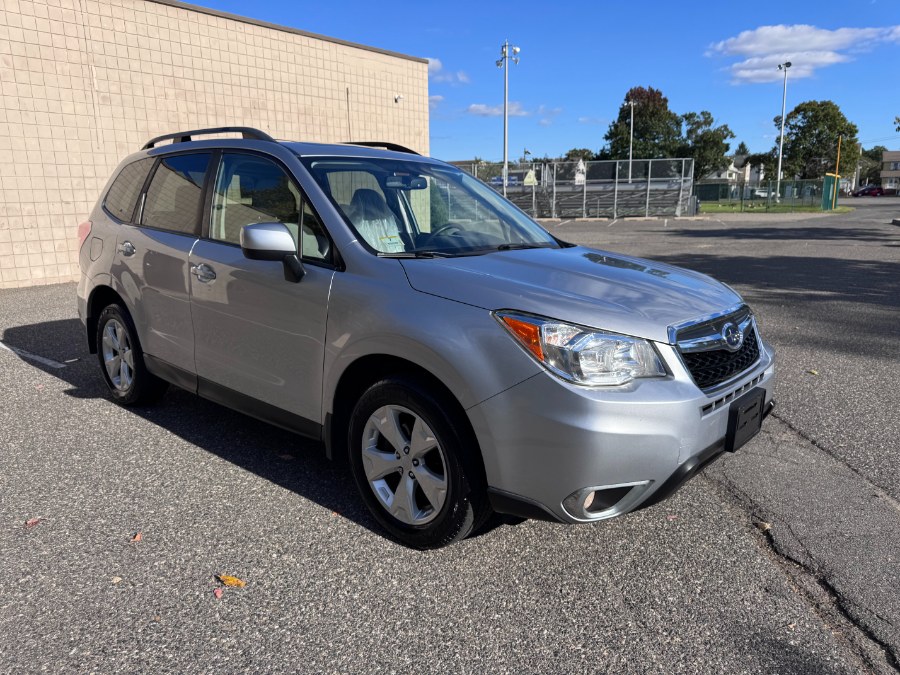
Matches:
[[775, 101, 859, 178]]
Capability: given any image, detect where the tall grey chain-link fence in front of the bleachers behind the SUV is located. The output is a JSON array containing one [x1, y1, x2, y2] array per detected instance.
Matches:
[[455, 158, 694, 218]]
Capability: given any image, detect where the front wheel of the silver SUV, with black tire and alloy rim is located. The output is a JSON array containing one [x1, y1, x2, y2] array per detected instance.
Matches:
[[349, 376, 490, 549]]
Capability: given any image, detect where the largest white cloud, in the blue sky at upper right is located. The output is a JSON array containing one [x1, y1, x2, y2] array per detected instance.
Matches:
[[706, 24, 900, 84]]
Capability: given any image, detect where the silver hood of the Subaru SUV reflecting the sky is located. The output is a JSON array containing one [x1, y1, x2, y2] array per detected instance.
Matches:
[[401, 246, 741, 342]]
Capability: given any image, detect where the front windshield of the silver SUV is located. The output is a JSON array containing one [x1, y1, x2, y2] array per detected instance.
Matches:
[[301, 157, 559, 257]]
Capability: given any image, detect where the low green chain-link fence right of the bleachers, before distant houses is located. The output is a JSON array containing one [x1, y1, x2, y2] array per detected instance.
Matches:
[[694, 180, 830, 213]]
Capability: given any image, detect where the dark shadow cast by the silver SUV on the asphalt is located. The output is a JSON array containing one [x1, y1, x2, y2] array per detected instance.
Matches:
[[0, 319, 501, 548]]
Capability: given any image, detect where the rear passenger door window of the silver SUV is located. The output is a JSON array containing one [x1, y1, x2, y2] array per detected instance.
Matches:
[[141, 152, 212, 237]]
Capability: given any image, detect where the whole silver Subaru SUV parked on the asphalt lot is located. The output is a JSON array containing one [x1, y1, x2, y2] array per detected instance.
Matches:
[[78, 127, 774, 548]]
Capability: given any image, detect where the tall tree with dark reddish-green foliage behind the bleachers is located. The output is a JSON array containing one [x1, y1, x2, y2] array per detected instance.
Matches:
[[601, 87, 682, 159]]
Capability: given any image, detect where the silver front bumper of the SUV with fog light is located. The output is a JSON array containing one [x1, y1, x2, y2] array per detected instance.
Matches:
[[468, 345, 775, 523]]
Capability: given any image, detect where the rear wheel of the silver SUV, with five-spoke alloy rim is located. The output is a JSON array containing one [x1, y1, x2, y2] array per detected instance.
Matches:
[[97, 303, 169, 406]]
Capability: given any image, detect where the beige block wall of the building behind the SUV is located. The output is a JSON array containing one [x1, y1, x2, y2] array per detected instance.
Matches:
[[0, 0, 428, 288]]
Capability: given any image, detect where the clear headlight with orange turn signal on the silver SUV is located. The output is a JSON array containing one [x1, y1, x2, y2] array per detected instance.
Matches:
[[494, 311, 666, 386]]
